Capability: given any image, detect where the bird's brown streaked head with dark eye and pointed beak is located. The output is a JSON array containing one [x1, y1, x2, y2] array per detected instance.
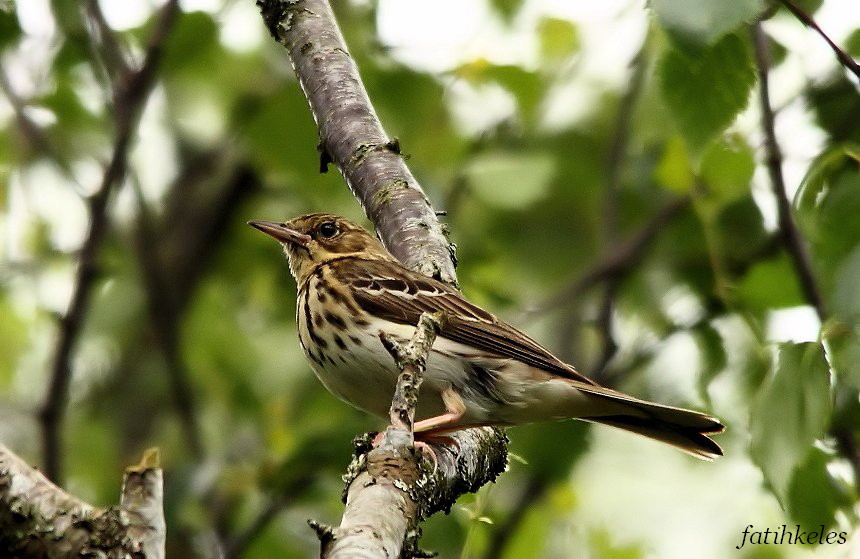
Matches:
[[248, 213, 394, 285]]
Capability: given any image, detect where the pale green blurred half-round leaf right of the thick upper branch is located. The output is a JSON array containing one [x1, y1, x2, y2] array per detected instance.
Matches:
[[465, 151, 555, 210]]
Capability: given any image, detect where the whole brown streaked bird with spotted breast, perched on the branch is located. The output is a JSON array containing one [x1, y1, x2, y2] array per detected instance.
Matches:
[[249, 213, 723, 459]]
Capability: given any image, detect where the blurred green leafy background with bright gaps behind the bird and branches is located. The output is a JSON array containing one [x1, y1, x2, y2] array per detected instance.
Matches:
[[0, 0, 860, 559]]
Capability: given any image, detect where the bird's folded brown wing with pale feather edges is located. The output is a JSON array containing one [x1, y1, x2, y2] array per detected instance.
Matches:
[[333, 259, 596, 385]]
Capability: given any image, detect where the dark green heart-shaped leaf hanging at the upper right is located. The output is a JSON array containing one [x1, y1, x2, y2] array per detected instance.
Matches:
[[657, 35, 755, 155]]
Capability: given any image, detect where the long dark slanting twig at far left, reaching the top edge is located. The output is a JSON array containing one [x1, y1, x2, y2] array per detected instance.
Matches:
[[39, 0, 179, 480]]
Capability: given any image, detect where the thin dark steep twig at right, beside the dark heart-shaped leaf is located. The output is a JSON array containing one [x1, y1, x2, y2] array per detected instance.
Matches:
[[752, 23, 827, 322]]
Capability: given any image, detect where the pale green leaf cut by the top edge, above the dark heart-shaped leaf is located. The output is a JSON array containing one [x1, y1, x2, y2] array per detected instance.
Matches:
[[649, 0, 763, 45]]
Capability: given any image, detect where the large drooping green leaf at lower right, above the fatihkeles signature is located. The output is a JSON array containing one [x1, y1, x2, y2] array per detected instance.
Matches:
[[750, 343, 831, 507]]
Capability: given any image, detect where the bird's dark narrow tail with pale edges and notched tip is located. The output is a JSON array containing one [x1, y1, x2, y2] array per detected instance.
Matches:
[[579, 386, 724, 460]]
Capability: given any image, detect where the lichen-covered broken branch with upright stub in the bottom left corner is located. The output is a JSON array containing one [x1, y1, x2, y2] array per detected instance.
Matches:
[[0, 444, 166, 559]]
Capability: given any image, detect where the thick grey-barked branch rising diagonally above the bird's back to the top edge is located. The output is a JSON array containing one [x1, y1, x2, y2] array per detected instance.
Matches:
[[257, 0, 457, 285]]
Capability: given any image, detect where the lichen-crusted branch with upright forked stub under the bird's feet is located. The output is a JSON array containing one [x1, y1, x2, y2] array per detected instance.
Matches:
[[320, 313, 507, 559]]
